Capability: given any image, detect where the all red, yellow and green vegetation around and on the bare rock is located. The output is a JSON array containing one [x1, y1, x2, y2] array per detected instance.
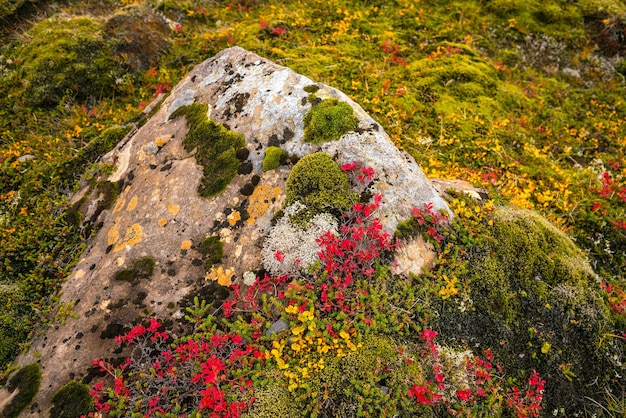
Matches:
[[0, 0, 626, 416]]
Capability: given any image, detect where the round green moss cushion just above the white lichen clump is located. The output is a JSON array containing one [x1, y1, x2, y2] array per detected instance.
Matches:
[[286, 152, 357, 220]]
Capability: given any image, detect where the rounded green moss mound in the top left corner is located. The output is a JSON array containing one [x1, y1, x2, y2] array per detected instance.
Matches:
[[18, 16, 123, 106]]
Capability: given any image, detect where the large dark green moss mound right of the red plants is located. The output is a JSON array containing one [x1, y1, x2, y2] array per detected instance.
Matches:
[[439, 209, 621, 416]]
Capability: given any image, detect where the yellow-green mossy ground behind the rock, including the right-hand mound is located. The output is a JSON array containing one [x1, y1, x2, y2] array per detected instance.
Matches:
[[0, 0, 626, 416]]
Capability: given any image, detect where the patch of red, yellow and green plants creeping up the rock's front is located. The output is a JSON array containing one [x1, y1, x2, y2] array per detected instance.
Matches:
[[91, 163, 545, 417]]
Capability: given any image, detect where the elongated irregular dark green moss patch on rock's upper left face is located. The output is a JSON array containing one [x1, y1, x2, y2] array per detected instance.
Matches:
[[170, 103, 246, 198]]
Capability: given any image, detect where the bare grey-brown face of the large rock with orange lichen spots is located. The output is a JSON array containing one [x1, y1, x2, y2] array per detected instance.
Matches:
[[17, 47, 447, 417]]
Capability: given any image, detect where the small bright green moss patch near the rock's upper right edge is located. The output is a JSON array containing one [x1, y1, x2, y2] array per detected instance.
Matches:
[[304, 99, 358, 144]]
